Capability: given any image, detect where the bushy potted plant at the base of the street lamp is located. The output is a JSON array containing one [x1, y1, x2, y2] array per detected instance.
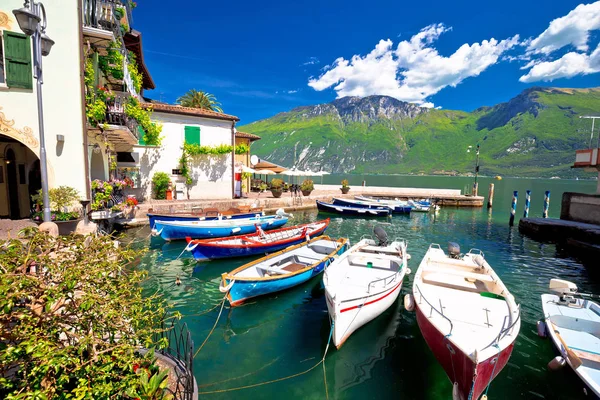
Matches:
[[31, 186, 81, 236]]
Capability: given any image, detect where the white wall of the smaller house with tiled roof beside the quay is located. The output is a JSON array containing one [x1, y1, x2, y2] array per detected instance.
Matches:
[[134, 111, 233, 200]]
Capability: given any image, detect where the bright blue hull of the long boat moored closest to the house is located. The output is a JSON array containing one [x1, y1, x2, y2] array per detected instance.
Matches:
[[154, 218, 288, 240]]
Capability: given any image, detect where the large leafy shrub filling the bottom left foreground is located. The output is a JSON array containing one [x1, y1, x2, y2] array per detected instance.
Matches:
[[0, 228, 171, 399]]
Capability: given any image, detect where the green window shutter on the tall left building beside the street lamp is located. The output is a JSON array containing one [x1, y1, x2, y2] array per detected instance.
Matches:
[[4, 31, 33, 89]]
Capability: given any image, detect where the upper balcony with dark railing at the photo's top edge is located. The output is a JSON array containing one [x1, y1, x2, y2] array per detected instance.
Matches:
[[82, 0, 131, 43]]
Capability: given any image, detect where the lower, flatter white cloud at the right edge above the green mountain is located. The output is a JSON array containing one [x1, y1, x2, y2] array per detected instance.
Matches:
[[519, 45, 600, 83]]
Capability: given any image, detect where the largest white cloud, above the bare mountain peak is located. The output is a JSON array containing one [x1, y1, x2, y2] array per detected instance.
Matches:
[[308, 24, 519, 107]]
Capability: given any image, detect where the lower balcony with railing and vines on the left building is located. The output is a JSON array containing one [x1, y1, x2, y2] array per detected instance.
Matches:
[[89, 92, 139, 151]]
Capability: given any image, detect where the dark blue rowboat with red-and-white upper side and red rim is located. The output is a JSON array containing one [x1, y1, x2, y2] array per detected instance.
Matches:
[[186, 218, 329, 261]]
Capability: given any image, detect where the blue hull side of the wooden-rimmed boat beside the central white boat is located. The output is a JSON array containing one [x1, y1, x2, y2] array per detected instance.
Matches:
[[222, 244, 348, 307]]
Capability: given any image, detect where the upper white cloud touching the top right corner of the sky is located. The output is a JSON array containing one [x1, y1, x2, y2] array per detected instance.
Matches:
[[527, 1, 600, 54]]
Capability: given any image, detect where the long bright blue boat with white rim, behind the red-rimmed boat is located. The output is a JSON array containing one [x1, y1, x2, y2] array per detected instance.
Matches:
[[152, 215, 288, 240]]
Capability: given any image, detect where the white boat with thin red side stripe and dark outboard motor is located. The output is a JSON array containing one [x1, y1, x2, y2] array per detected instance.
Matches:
[[323, 227, 408, 349]]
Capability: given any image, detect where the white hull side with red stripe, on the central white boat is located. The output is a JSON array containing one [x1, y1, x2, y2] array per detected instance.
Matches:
[[325, 280, 403, 349]]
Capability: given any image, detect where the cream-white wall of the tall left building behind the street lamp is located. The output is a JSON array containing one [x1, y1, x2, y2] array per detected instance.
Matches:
[[0, 0, 86, 202]]
